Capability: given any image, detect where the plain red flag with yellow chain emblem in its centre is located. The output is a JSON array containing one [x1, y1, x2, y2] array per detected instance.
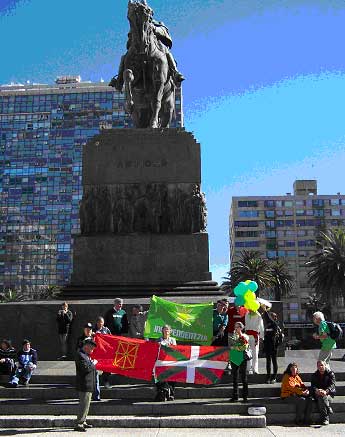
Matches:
[[91, 334, 159, 381]]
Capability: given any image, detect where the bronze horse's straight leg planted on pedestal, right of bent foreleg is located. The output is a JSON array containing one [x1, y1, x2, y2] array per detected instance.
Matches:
[[150, 57, 169, 128]]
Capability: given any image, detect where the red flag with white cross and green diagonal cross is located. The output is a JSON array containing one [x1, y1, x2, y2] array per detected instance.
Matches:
[[154, 346, 229, 385]]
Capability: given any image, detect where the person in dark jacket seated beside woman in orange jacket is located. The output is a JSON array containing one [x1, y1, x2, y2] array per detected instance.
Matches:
[[310, 361, 335, 425]]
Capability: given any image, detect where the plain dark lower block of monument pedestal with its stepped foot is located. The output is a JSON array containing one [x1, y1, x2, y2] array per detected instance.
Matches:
[[64, 233, 219, 299]]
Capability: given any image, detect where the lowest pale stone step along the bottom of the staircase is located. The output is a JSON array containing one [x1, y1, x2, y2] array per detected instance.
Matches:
[[0, 413, 266, 428]]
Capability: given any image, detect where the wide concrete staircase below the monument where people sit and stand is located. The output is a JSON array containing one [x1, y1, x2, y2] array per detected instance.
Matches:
[[0, 373, 345, 428]]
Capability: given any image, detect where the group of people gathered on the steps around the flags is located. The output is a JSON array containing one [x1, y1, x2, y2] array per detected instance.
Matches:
[[0, 298, 336, 431]]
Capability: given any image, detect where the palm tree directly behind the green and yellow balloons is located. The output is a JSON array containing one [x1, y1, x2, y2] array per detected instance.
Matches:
[[222, 250, 272, 295]]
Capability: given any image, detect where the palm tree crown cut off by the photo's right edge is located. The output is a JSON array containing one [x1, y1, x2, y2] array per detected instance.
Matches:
[[306, 229, 345, 303]]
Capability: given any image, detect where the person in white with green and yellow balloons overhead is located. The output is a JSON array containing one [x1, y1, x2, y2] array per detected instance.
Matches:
[[234, 280, 264, 374]]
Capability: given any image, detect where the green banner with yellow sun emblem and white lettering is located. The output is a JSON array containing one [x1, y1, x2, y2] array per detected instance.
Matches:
[[144, 296, 213, 345]]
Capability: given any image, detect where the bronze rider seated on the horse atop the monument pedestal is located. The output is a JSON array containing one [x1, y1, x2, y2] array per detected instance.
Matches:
[[109, 0, 185, 91]]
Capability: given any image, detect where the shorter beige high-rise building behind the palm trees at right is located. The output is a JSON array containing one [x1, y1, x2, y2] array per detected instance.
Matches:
[[230, 180, 345, 322]]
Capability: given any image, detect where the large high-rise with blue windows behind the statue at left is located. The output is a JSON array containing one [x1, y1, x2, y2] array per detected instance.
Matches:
[[0, 76, 183, 291]]
